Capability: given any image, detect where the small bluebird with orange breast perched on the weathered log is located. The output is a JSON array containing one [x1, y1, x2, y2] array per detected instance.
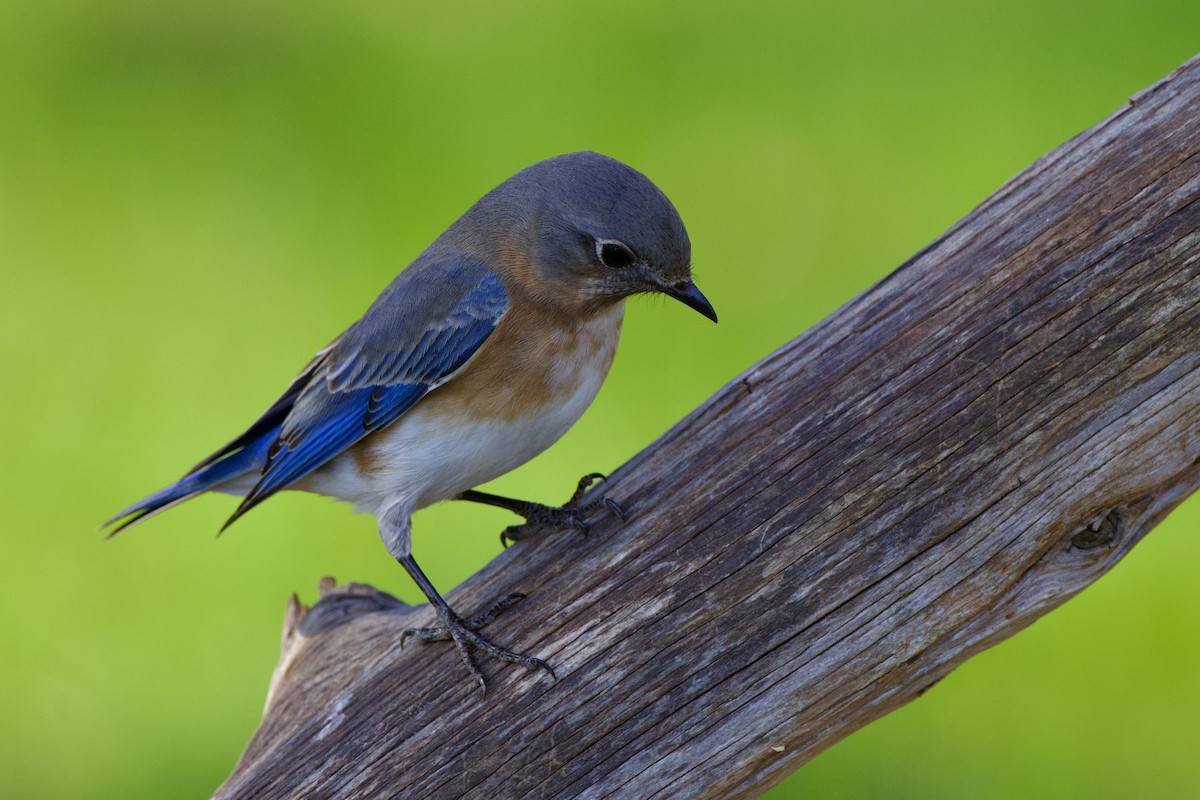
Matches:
[[106, 152, 716, 691]]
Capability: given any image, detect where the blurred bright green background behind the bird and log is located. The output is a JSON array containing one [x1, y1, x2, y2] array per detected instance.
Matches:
[[0, 0, 1200, 800]]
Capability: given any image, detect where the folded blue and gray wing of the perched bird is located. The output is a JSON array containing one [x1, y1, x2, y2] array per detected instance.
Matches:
[[218, 253, 509, 527]]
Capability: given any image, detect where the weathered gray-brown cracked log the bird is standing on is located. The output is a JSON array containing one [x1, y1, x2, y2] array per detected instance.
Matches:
[[217, 58, 1200, 798]]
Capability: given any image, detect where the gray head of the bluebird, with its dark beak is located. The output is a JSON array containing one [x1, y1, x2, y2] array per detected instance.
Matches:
[[446, 152, 716, 321]]
